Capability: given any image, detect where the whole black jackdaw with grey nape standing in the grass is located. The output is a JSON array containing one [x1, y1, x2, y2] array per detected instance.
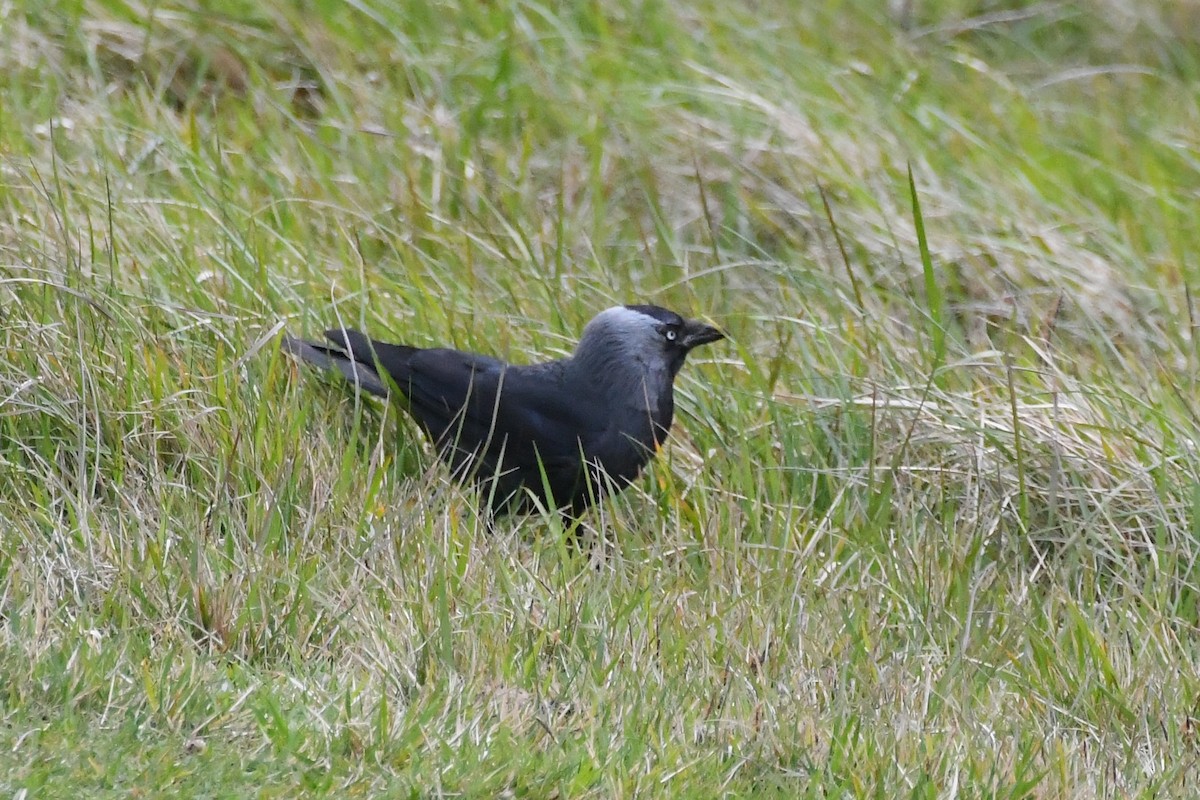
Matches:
[[280, 305, 725, 518]]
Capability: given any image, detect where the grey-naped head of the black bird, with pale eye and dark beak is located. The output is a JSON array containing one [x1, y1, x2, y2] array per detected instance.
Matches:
[[575, 306, 725, 378]]
